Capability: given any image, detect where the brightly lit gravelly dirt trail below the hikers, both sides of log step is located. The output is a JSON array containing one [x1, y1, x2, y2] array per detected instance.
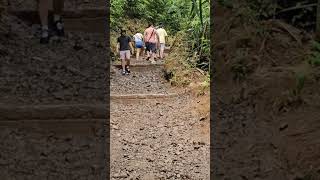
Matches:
[[110, 60, 210, 180]]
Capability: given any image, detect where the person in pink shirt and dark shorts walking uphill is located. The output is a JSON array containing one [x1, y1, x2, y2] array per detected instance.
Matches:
[[144, 23, 159, 63]]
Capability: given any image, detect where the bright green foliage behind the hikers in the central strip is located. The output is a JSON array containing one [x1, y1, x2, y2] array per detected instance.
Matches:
[[111, 0, 210, 71]]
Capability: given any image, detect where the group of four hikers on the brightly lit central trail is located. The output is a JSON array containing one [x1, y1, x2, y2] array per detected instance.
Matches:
[[117, 23, 168, 75]]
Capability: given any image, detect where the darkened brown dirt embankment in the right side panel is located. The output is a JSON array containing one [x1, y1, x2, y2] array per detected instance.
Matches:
[[212, 3, 320, 179]]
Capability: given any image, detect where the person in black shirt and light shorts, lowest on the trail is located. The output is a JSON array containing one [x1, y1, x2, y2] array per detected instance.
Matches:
[[117, 30, 134, 75]]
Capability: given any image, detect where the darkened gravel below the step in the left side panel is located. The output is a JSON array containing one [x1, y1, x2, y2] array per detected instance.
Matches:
[[0, 124, 105, 180]]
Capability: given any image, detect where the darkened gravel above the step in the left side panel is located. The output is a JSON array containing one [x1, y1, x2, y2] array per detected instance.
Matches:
[[0, 15, 108, 104]]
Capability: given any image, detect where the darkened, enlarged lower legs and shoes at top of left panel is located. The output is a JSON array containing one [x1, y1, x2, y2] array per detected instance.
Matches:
[[39, 0, 64, 44]]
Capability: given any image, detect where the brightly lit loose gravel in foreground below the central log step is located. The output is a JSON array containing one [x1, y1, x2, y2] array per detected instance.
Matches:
[[111, 96, 210, 179]]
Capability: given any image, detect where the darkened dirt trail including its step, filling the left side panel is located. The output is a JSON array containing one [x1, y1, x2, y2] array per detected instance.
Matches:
[[0, 5, 109, 180]]
